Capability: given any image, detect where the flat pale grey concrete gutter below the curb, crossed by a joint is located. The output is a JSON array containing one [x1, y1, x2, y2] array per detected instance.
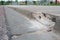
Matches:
[[5, 7, 60, 40]]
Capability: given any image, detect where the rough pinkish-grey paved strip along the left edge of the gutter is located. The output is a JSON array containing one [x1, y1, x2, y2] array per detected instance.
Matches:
[[0, 6, 8, 40]]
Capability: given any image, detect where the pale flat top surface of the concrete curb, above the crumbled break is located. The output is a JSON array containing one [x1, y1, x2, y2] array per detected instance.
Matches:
[[8, 5, 60, 16]]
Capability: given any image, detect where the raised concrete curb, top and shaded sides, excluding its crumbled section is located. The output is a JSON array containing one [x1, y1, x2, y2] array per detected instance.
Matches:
[[11, 6, 60, 35]]
